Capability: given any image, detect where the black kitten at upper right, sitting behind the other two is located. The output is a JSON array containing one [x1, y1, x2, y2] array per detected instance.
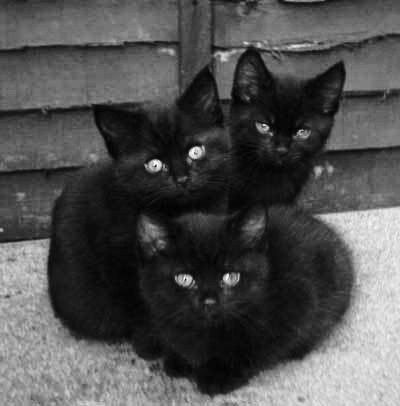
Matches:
[[230, 48, 345, 209]]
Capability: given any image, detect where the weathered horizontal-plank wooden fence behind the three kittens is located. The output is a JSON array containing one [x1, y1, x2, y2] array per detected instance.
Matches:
[[0, 0, 400, 241]]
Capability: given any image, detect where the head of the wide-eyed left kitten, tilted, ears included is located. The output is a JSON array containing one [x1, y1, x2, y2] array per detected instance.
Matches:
[[94, 67, 230, 208]]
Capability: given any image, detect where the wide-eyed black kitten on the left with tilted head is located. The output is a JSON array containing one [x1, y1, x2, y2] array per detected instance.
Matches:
[[48, 69, 229, 339]]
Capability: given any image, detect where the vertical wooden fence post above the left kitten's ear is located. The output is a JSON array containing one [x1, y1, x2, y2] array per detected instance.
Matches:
[[179, 0, 212, 93]]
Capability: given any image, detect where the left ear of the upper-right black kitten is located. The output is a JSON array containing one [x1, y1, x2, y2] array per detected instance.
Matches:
[[232, 47, 274, 103]]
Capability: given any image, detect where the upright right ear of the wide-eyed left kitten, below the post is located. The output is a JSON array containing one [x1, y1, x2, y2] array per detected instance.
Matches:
[[176, 66, 223, 125]]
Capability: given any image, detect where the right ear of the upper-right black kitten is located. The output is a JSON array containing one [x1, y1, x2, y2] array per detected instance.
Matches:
[[306, 61, 346, 115]]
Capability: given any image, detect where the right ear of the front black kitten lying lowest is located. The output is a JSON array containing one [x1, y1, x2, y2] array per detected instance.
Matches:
[[231, 206, 268, 248]]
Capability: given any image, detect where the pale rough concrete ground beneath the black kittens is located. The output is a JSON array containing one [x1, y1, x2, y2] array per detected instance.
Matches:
[[0, 208, 400, 406]]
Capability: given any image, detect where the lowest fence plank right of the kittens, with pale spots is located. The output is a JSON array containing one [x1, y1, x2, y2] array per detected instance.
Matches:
[[300, 149, 400, 213]]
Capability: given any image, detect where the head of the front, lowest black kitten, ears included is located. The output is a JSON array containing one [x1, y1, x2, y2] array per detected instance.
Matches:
[[138, 208, 268, 331]]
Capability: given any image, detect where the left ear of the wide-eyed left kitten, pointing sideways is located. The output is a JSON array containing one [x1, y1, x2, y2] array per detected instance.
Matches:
[[93, 105, 143, 159]]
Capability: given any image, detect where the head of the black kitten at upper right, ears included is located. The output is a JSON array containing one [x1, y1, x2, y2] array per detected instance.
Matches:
[[231, 48, 345, 169]]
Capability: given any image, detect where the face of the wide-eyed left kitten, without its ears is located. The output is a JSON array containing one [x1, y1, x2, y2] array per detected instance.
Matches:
[[117, 109, 229, 206]]
